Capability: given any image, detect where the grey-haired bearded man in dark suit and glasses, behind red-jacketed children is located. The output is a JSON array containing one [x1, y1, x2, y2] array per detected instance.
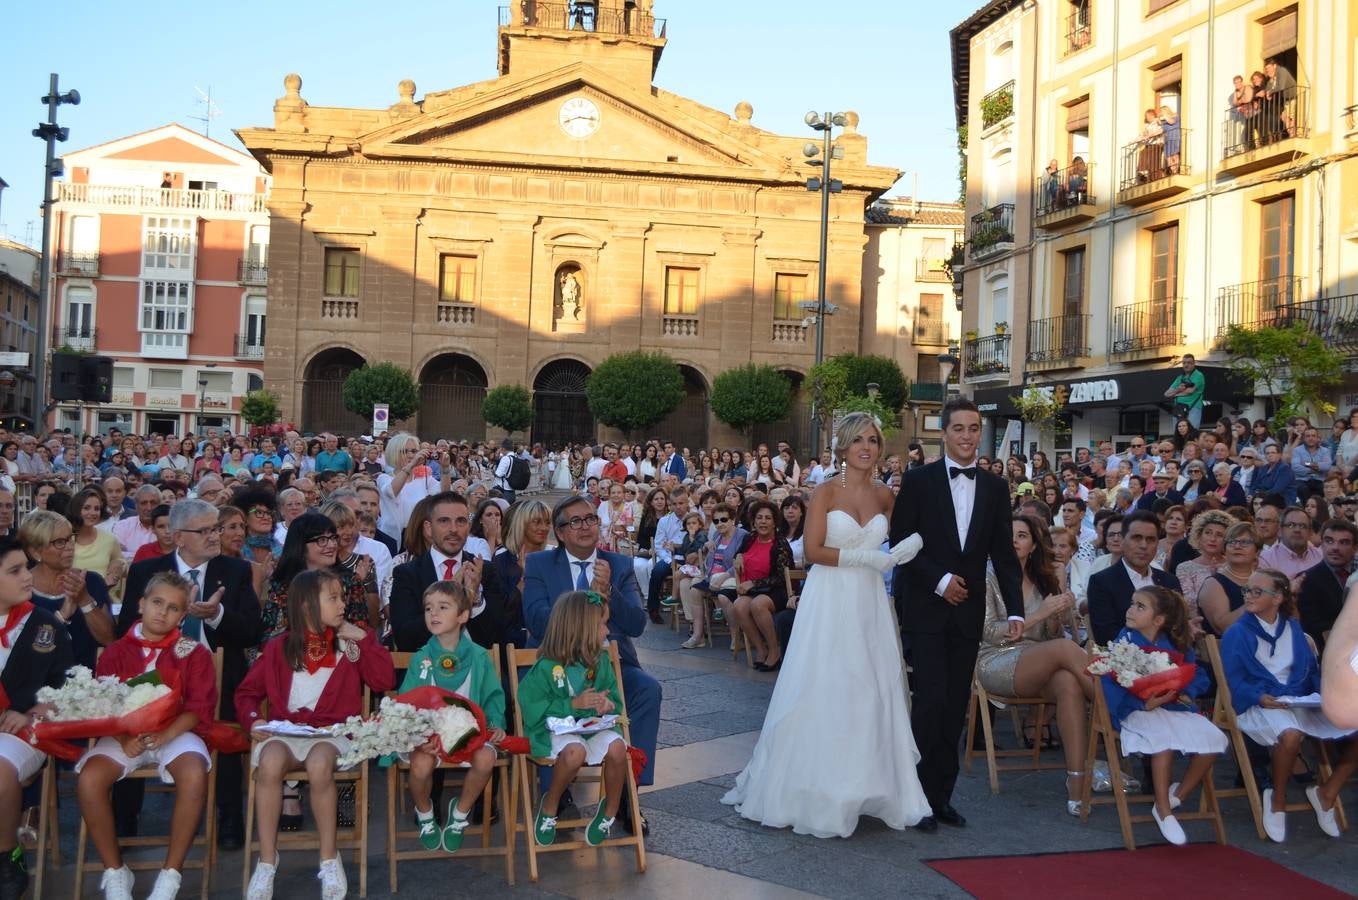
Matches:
[[114, 500, 263, 850]]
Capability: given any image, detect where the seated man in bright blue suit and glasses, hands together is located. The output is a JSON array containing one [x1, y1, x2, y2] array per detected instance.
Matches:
[[523, 497, 660, 823]]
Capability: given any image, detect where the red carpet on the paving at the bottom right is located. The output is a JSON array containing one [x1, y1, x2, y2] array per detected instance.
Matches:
[[928, 844, 1350, 900]]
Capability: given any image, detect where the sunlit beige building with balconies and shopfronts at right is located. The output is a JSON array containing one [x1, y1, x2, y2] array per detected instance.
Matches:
[[952, 0, 1358, 452]]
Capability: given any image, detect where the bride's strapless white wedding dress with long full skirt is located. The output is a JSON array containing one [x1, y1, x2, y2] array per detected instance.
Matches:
[[721, 509, 930, 838]]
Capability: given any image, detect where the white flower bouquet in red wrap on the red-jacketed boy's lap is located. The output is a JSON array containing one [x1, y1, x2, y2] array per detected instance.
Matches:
[[33, 665, 181, 740]]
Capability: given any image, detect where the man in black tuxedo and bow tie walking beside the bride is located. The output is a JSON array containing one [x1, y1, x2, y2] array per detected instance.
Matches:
[[891, 399, 1024, 832]]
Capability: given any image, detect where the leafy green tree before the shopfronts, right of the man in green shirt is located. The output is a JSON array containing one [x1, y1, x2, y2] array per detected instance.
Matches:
[[1226, 322, 1344, 428]]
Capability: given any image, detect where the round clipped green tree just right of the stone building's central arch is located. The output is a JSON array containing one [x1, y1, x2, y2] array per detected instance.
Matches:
[[585, 350, 684, 434]]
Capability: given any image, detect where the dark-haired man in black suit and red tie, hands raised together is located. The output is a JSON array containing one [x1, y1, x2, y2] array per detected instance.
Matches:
[[387, 490, 519, 652]]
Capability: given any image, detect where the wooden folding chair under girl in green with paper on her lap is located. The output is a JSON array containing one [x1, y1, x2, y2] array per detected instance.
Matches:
[[509, 648, 646, 881]]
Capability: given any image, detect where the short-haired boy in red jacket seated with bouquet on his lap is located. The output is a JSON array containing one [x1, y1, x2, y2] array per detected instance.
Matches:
[[76, 571, 217, 900]]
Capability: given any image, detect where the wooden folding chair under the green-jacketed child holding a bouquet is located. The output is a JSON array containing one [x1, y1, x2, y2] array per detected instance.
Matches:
[[387, 643, 517, 893]]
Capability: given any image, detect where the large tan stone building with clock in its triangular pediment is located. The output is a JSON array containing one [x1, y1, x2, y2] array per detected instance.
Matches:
[[238, 0, 909, 451]]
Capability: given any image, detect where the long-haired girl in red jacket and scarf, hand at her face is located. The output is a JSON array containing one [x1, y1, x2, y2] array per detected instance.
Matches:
[[236, 569, 397, 900]]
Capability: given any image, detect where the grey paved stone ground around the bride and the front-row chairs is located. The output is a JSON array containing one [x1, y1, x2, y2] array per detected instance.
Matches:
[[29, 597, 1358, 900]]
